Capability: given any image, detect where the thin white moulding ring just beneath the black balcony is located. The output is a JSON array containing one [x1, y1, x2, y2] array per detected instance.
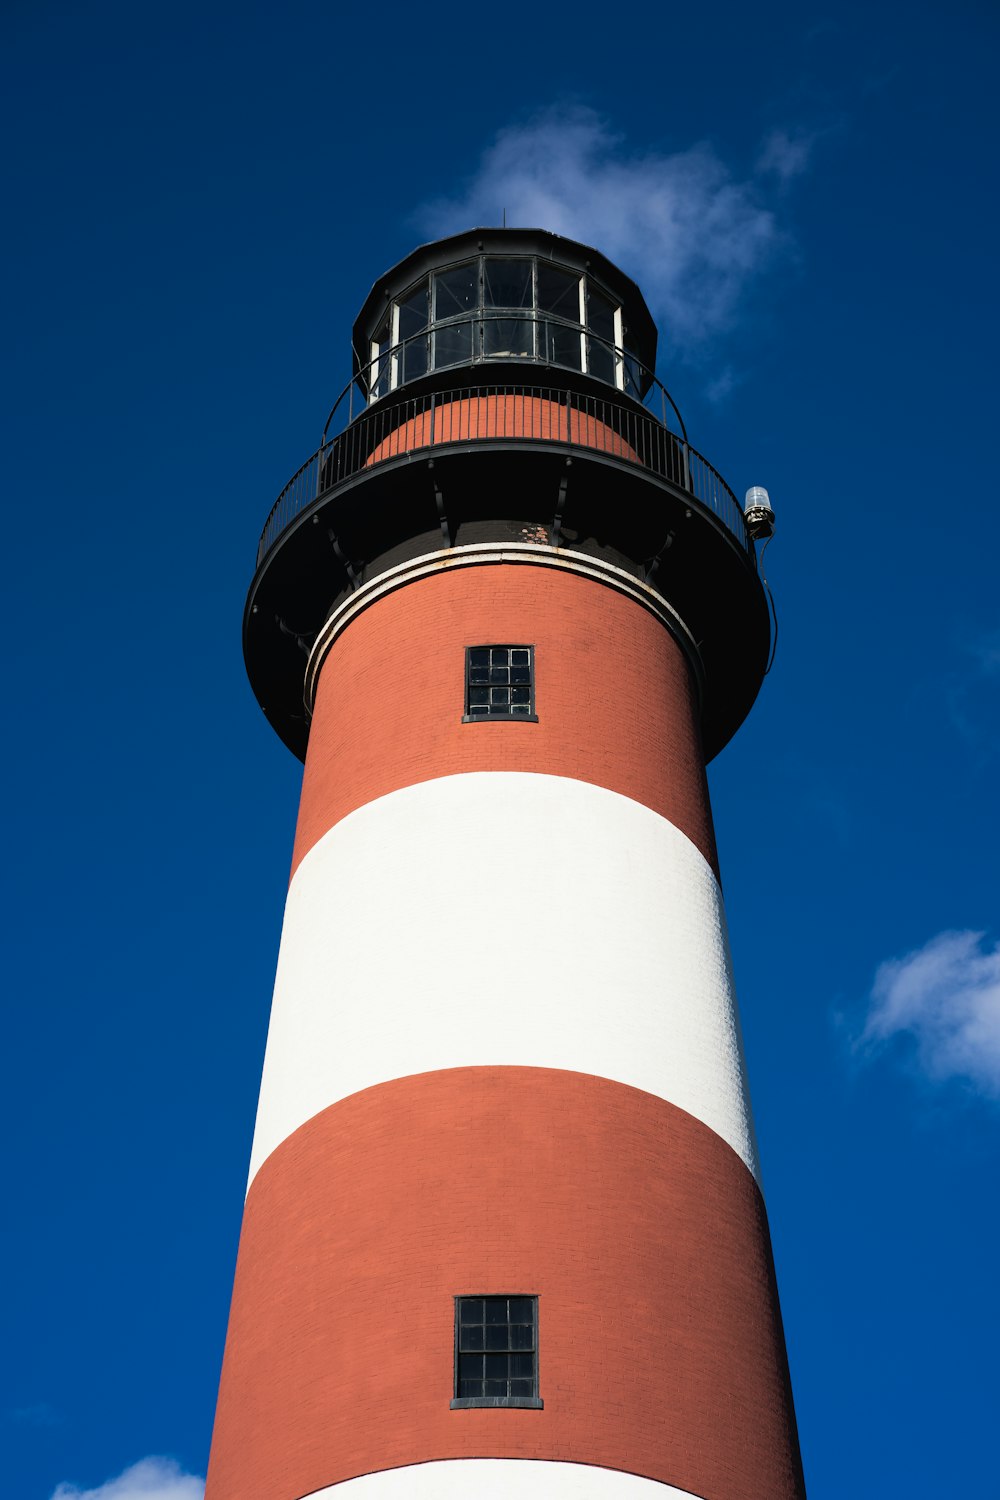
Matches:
[[303, 542, 705, 713]]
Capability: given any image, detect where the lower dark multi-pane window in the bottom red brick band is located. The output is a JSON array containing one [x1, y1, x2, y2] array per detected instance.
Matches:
[[451, 1298, 543, 1409]]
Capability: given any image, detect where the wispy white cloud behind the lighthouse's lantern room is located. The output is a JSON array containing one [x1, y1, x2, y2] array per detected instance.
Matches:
[[417, 105, 808, 351]]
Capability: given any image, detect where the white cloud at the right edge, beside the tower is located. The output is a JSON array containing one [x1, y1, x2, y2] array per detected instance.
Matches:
[[859, 932, 1000, 1097]]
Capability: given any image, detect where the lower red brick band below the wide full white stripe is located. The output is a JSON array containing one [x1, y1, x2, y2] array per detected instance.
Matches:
[[207, 1068, 804, 1500]]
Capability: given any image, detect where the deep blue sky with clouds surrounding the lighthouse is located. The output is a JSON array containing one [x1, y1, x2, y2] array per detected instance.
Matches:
[[0, 0, 1000, 1500]]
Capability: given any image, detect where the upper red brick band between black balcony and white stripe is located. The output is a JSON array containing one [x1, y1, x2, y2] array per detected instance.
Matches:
[[292, 564, 717, 872]]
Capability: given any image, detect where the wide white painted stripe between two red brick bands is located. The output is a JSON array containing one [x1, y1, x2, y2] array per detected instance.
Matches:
[[250, 774, 757, 1179]]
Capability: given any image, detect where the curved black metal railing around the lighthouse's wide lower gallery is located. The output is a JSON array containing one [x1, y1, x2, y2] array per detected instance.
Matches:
[[256, 386, 754, 567]]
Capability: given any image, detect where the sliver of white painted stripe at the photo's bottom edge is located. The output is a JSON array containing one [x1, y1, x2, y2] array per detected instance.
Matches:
[[304, 1458, 700, 1500]]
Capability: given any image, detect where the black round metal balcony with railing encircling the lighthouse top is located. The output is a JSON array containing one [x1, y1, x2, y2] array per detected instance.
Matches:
[[243, 334, 771, 758]]
